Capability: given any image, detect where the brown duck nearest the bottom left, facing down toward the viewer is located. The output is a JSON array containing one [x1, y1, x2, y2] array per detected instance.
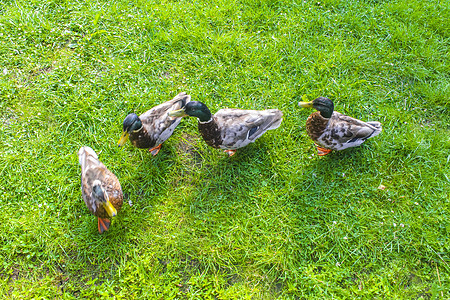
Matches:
[[78, 146, 123, 234]]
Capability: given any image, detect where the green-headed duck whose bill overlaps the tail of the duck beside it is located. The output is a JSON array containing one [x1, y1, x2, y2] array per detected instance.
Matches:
[[169, 101, 283, 157]]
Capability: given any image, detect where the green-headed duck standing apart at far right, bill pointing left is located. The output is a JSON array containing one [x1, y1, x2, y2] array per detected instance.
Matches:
[[298, 97, 382, 156]]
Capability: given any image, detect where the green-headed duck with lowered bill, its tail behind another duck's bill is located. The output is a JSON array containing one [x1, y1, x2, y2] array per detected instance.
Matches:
[[117, 92, 191, 156]]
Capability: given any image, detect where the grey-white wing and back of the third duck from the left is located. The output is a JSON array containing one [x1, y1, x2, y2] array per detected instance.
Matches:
[[214, 109, 283, 149]]
